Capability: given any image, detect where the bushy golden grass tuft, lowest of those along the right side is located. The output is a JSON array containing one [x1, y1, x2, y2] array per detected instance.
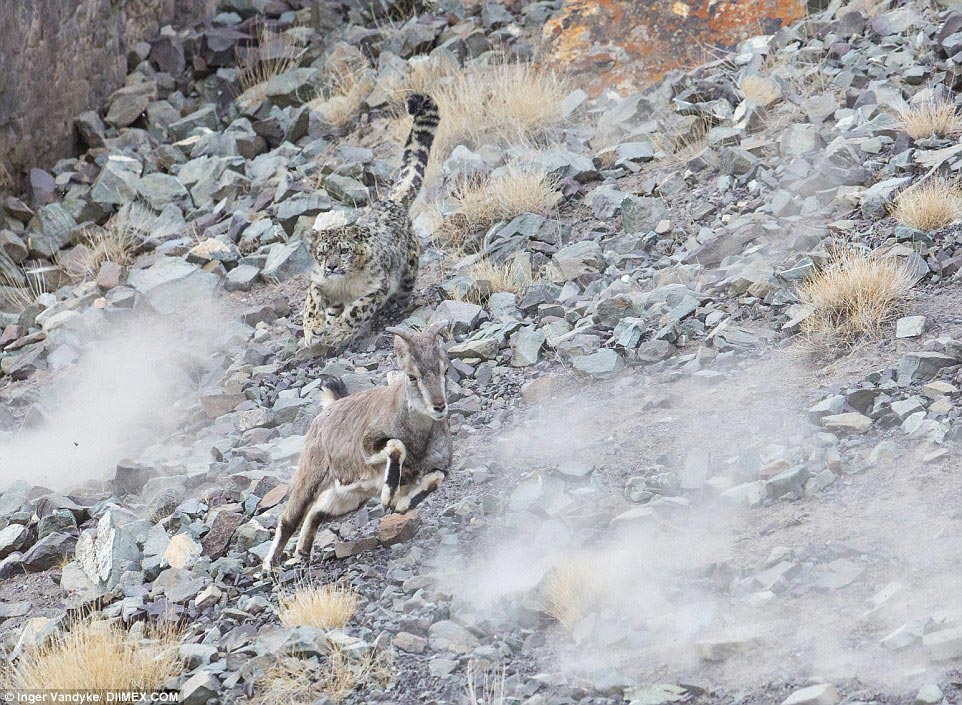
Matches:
[[799, 248, 912, 350]]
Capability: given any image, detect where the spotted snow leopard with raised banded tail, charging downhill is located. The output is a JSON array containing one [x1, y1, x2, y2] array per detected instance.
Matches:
[[304, 94, 439, 351]]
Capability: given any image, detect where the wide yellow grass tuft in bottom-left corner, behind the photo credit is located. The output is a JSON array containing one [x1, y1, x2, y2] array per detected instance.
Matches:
[[0, 622, 181, 692]]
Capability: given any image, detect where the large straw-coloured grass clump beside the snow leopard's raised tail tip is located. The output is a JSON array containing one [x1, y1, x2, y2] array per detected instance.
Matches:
[[397, 59, 570, 162]]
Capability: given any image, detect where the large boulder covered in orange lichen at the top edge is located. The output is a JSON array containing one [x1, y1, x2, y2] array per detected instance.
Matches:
[[544, 0, 805, 95]]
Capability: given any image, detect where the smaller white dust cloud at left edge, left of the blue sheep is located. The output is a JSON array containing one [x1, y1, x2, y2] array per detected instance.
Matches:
[[0, 302, 228, 490]]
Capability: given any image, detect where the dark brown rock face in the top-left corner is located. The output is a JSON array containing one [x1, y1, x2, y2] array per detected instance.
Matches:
[[0, 0, 212, 191]]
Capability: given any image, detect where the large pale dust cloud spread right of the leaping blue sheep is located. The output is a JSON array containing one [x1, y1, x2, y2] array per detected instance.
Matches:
[[435, 360, 962, 688]]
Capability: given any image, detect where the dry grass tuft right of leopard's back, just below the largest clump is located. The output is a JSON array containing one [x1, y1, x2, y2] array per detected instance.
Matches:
[[438, 165, 561, 250]]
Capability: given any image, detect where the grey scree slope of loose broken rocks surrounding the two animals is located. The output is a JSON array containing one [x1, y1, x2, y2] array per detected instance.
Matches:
[[0, 0, 962, 705]]
